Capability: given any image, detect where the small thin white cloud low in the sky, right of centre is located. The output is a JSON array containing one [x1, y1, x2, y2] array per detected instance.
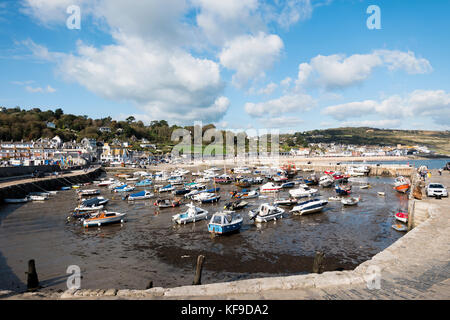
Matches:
[[244, 94, 317, 117]]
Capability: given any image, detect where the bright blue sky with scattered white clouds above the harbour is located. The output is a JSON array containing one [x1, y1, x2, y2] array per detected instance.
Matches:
[[0, 0, 450, 132]]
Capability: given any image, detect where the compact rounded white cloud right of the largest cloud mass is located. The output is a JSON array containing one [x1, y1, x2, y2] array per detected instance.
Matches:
[[219, 32, 283, 87]]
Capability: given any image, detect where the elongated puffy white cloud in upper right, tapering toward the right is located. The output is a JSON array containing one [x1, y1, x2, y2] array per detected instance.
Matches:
[[296, 50, 432, 90]]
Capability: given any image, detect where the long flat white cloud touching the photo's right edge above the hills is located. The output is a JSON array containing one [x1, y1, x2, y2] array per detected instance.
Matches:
[[322, 90, 450, 124]]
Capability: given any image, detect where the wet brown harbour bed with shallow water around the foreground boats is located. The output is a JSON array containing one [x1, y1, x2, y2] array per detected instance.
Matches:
[[0, 173, 407, 291]]
